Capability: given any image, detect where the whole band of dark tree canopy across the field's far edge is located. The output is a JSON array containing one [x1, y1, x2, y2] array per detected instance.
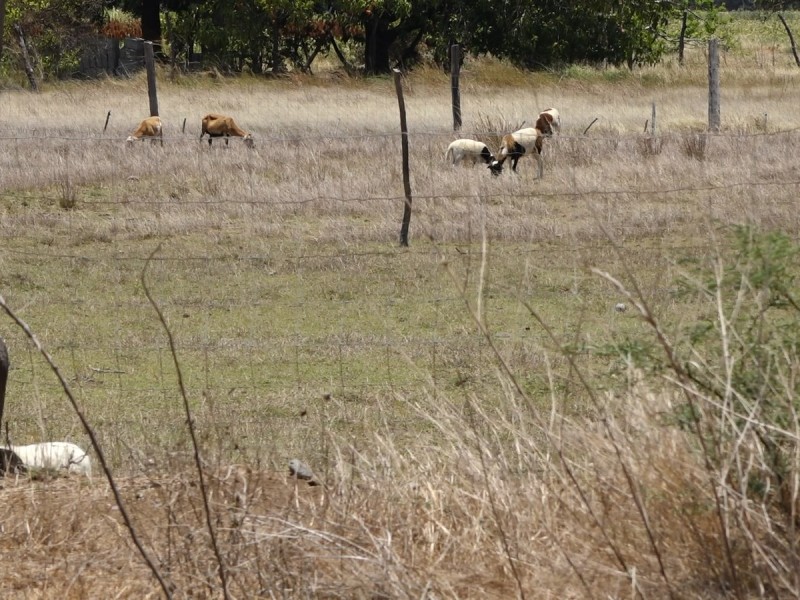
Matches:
[[0, 0, 720, 79]]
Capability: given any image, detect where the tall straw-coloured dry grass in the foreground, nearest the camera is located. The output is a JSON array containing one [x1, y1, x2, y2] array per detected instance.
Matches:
[[0, 388, 797, 598]]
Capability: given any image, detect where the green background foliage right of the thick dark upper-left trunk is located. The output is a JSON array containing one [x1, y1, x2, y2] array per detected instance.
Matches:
[[120, 0, 716, 73]]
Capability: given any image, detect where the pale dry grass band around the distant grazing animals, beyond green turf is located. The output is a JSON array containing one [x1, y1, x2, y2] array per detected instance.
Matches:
[[0, 70, 798, 242]]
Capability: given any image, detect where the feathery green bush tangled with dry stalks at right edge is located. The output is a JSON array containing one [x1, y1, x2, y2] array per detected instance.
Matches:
[[613, 226, 800, 511]]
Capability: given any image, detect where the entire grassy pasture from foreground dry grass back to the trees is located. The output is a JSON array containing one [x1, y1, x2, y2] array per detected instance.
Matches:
[[0, 22, 800, 598]]
